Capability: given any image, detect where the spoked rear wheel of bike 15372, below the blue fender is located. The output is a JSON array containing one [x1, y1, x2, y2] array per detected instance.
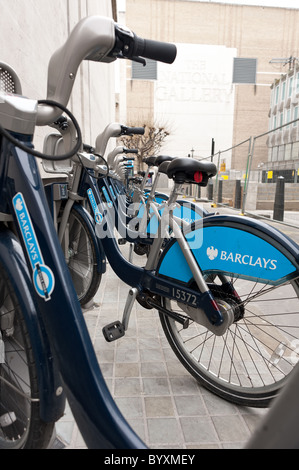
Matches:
[[160, 273, 299, 408]]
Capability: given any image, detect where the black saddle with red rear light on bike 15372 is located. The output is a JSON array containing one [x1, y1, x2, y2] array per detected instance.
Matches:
[[167, 157, 217, 186]]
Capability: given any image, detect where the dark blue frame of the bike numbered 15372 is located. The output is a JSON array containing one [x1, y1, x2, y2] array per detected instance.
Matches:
[[79, 167, 227, 324]]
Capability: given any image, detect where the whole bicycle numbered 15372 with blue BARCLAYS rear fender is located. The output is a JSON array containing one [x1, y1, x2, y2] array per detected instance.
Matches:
[[45, 123, 299, 407]]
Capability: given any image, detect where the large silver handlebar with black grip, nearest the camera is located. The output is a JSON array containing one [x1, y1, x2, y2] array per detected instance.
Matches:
[[36, 16, 176, 126]]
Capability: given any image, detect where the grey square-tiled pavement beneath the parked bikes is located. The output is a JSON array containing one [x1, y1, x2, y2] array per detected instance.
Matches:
[[57, 270, 265, 449]]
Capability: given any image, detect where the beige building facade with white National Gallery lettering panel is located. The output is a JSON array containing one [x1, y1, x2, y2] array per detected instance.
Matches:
[[120, 0, 299, 170]]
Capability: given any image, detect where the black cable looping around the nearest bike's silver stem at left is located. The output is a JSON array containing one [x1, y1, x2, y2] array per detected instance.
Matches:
[[0, 100, 82, 161]]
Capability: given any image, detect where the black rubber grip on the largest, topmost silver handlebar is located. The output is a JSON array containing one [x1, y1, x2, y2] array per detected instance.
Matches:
[[134, 34, 177, 64]]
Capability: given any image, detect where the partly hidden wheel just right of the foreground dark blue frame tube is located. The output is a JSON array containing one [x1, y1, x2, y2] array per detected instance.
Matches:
[[63, 209, 102, 306]]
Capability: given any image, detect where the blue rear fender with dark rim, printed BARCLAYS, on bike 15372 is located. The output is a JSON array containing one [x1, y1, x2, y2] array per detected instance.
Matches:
[[157, 215, 299, 285]]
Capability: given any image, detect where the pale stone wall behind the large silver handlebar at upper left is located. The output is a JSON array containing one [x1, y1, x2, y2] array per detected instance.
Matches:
[[0, 0, 115, 176]]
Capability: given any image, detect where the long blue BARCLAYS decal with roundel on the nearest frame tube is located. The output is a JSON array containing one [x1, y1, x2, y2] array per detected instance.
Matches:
[[13, 193, 55, 301]]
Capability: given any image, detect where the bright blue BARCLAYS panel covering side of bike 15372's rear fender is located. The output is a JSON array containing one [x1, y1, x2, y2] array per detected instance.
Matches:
[[159, 226, 296, 284]]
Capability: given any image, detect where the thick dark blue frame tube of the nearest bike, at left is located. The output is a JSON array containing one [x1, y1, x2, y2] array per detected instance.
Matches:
[[5, 139, 145, 449]]
